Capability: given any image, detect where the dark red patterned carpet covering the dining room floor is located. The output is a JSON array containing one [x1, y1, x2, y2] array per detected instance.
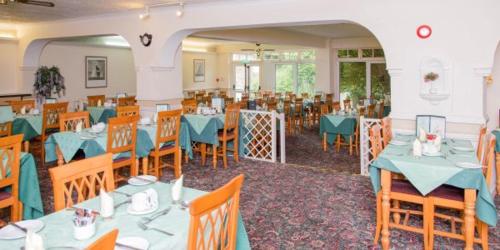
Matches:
[[28, 128, 500, 249]]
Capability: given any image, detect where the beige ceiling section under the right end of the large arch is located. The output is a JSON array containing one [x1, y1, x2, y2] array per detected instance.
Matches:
[[281, 23, 373, 38]]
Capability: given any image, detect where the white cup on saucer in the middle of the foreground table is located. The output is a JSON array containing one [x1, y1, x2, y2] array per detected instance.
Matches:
[[127, 188, 159, 215]]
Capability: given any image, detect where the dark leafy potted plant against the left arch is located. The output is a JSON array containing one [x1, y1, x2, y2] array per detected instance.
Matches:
[[33, 66, 66, 104]]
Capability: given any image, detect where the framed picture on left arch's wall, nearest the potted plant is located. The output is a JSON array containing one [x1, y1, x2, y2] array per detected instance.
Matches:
[[85, 56, 108, 88]]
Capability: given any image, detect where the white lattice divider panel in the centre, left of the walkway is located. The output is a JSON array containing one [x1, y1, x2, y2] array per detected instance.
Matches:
[[240, 110, 286, 163]]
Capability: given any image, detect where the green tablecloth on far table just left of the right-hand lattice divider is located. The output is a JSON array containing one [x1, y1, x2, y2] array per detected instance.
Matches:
[[319, 115, 356, 144]]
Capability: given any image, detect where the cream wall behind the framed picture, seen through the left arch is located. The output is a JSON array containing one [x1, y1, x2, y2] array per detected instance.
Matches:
[[40, 43, 136, 104]]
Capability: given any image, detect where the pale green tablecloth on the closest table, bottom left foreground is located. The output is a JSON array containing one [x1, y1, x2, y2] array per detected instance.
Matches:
[[0, 183, 250, 250]]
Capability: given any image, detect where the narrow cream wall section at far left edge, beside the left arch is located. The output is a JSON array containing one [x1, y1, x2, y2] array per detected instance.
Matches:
[[0, 40, 18, 94]]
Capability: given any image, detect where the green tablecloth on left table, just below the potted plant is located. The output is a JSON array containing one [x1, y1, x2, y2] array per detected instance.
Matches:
[[12, 115, 43, 141]]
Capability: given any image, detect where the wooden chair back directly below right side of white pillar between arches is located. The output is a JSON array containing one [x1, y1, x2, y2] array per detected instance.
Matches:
[[155, 109, 182, 150]]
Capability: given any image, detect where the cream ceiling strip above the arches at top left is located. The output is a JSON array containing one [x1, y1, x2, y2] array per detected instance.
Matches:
[[0, 0, 224, 23]]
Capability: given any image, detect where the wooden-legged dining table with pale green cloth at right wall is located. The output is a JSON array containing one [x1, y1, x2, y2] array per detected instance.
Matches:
[[369, 135, 497, 249]]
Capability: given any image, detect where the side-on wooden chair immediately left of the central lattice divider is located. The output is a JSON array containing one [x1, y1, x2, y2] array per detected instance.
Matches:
[[213, 105, 240, 168]]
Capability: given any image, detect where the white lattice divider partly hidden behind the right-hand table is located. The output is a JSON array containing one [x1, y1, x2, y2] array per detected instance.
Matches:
[[359, 117, 382, 176]]
